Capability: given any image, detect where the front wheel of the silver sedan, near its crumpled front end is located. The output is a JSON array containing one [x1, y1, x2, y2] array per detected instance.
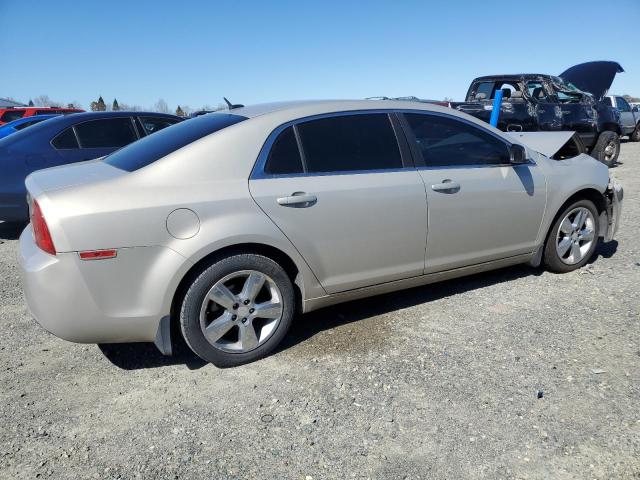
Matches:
[[543, 200, 600, 273]]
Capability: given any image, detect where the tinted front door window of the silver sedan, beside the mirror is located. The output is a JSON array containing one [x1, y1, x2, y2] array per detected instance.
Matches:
[[405, 113, 510, 167]]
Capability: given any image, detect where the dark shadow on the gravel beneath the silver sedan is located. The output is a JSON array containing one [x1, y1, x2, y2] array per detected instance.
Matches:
[[98, 240, 618, 370]]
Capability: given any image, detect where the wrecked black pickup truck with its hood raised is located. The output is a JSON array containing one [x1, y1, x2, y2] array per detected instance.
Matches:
[[451, 61, 624, 167]]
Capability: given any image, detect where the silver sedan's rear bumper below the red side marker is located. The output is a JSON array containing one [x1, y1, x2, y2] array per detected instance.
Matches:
[[20, 225, 185, 343]]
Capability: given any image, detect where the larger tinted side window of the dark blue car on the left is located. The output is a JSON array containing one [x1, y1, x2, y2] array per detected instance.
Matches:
[[76, 117, 138, 148]]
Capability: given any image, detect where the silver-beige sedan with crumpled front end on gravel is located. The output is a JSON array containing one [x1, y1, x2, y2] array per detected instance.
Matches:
[[20, 101, 622, 366]]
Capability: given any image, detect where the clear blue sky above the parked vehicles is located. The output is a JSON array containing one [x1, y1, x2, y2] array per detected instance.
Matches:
[[0, 0, 640, 108]]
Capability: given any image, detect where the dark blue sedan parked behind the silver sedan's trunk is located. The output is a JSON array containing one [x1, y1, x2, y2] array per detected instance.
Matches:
[[0, 112, 183, 222]]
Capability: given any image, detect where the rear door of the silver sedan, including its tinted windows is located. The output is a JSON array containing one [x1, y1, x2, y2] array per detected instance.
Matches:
[[249, 113, 427, 293]]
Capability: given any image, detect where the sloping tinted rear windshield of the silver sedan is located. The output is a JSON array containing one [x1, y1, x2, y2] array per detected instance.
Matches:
[[104, 113, 247, 172]]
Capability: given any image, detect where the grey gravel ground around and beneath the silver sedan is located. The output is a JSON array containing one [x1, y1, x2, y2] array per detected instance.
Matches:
[[0, 143, 640, 479]]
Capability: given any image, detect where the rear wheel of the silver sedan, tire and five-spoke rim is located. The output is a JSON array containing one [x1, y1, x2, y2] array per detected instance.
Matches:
[[180, 254, 296, 367]]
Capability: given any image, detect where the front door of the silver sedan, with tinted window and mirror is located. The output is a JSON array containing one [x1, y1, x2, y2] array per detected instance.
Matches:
[[404, 113, 546, 273]]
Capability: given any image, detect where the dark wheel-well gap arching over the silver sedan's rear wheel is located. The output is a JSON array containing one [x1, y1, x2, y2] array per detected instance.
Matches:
[[171, 243, 302, 326]]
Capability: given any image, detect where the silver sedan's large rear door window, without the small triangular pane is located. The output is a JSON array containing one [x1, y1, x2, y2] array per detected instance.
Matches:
[[297, 113, 402, 173]]
